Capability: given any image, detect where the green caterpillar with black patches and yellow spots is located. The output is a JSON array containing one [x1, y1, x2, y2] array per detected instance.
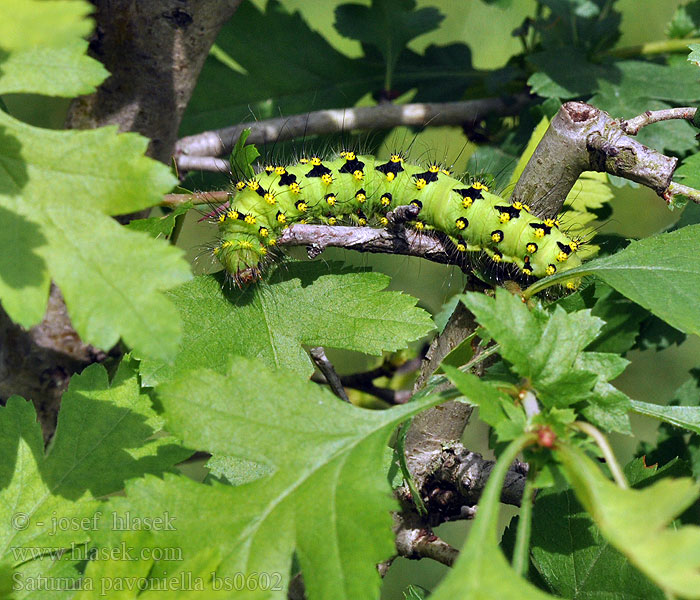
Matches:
[[213, 151, 582, 289]]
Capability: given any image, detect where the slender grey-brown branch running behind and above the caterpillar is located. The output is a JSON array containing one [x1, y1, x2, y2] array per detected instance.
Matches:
[[175, 94, 529, 171]]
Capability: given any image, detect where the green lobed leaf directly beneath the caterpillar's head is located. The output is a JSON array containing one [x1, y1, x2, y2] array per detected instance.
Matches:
[[141, 263, 434, 385]]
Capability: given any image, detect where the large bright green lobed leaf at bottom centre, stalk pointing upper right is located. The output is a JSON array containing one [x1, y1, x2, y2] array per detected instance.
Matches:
[[89, 358, 440, 600]]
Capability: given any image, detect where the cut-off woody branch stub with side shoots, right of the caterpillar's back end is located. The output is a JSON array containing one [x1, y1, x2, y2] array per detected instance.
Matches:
[[512, 102, 694, 217]]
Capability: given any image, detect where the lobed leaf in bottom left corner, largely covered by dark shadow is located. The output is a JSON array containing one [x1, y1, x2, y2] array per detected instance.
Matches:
[[0, 361, 186, 572]]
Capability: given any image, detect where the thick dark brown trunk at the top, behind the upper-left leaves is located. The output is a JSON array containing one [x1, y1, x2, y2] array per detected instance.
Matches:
[[68, 0, 241, 163]]
